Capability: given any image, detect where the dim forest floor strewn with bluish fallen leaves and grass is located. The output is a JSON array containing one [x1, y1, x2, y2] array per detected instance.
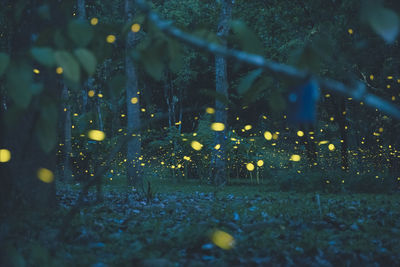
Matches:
[[3, 181, 400, 267]]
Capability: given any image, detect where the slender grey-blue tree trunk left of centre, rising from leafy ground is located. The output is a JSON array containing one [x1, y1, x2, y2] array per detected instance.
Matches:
[[125, 0, 143, 188]]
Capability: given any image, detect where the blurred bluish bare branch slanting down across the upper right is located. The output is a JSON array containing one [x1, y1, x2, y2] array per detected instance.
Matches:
[[135, 0, 400, 120]]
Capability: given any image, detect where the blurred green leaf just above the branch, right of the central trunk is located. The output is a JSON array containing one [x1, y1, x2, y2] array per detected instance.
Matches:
[[231, 20, 263, 54]]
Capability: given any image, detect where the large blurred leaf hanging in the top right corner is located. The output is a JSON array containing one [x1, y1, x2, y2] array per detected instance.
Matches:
[[362, 1, 400, 43]]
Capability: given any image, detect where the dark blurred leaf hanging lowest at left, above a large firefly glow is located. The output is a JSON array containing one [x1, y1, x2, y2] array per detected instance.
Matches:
[[35, 99, 58, 153]]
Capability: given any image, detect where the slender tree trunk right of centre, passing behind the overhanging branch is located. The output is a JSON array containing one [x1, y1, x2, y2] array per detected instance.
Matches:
[[211, 0, 233, 185]]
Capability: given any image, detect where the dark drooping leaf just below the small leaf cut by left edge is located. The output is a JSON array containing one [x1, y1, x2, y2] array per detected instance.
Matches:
[[6, 64, 32, 109]]
